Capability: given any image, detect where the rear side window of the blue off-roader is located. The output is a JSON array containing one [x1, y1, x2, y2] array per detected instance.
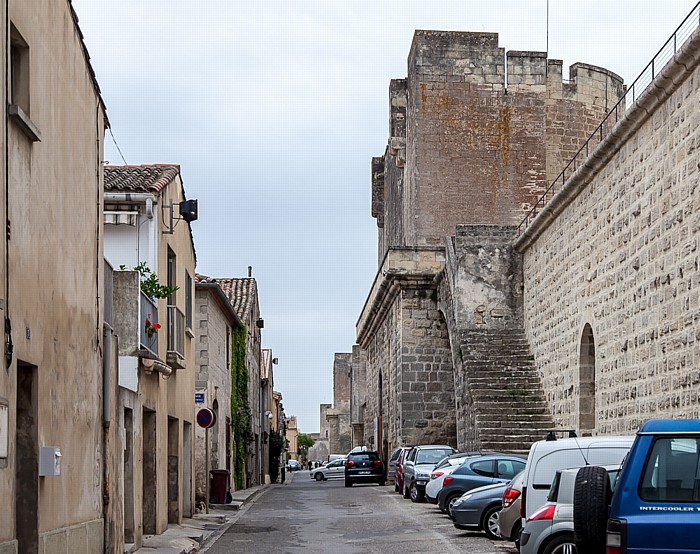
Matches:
[[639, 438, 700, 502]]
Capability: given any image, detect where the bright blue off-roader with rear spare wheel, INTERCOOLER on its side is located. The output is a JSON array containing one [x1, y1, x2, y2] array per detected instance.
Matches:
[[573, 419, 700, 554]]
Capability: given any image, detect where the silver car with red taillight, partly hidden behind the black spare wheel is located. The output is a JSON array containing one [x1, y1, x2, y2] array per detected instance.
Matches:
[[520, 465, 620, 554]]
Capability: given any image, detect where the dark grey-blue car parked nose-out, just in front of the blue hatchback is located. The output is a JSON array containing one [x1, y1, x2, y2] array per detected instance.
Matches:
[[450, 483, 508, 540]]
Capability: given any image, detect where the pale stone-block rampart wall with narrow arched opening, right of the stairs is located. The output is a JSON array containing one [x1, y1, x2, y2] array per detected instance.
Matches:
[[524, 45, 700, 433]]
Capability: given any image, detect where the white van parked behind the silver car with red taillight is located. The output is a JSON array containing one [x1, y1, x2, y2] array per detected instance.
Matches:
[[520, 436, 634, 518]]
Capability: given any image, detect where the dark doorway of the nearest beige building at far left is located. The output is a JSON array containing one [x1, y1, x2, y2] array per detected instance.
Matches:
[[15, 361, 39, 554]]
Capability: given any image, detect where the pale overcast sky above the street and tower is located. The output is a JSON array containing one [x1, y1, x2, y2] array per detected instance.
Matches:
[[73, 0, 696, 433]]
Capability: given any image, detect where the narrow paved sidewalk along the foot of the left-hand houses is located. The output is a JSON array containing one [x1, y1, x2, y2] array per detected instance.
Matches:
[[133, 475, 292, 554]]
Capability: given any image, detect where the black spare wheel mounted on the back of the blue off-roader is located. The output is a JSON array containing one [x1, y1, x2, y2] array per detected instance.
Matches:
[[574, 466, 612, 552]]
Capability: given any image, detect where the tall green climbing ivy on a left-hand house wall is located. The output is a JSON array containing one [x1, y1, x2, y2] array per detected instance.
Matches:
[[231, 325, 252, 490]]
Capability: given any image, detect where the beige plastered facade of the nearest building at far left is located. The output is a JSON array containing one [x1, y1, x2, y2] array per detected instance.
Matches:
[[0, 0, 105, 552]]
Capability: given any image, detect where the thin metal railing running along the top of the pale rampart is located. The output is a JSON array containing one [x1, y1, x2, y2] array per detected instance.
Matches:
[[518, 2, 700, 235]]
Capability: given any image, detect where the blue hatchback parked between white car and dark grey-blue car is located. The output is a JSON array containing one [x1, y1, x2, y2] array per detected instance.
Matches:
[[438, 454, 525, 515]]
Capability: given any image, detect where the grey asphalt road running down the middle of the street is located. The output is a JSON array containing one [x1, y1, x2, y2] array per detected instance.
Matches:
[[206, 471, 516, 554]]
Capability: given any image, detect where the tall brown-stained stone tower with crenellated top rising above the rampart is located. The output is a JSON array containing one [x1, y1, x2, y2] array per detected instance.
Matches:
[[372, 31, 624, 259]]
